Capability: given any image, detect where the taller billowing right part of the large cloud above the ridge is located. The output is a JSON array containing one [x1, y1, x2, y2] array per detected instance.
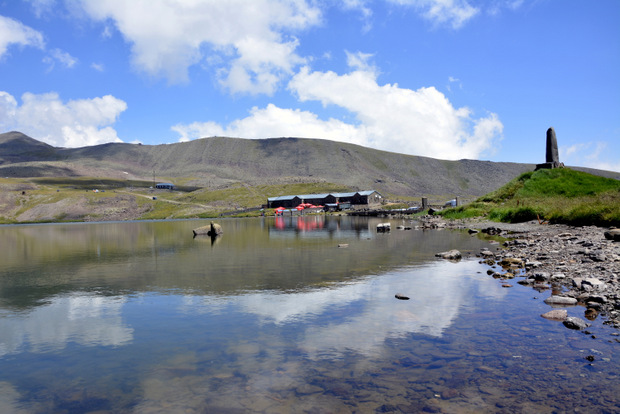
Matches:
[[289, 68, 503, 159]]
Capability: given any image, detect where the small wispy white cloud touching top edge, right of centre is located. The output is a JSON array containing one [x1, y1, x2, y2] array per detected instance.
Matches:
[[387, 0, 480, 29]]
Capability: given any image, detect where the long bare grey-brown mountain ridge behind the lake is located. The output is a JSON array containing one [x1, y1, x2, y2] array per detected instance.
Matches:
[[0, 131, 620, 196]]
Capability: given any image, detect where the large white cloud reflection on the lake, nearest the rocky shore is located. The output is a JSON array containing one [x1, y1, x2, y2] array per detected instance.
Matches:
[[181, 261, 506, 358]]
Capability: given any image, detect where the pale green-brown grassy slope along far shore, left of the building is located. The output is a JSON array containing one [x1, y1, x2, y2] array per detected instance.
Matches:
[[0, 177, 350, 224]]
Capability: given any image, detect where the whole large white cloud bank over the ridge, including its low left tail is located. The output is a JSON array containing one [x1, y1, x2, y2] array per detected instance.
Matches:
[[172, 63, 503, 159]]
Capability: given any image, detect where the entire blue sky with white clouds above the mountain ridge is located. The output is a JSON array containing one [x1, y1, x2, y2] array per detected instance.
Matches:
[[0, 0, 620, 171]]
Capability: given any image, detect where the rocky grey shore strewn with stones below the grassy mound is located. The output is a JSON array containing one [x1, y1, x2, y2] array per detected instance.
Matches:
[[422, 218, 620, 336]]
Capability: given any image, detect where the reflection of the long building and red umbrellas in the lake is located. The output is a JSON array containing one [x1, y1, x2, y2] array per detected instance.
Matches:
[[268, 216, 372, 238]]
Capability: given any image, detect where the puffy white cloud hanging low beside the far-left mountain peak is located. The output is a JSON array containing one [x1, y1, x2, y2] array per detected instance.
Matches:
[[0, 91, 127, 147]]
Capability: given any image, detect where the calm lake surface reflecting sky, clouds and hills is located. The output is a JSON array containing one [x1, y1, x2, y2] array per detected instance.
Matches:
[[0, 217, 620, 413]]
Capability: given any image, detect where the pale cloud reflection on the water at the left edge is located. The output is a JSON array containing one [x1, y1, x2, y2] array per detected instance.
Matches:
[[0, 294, 133, 356]]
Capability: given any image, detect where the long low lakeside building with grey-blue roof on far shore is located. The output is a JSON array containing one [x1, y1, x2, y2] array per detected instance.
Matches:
[[267, 190, 383, 208]]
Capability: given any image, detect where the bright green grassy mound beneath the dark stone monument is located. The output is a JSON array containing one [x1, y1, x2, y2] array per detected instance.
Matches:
[[442, 168, 620, 226]]
